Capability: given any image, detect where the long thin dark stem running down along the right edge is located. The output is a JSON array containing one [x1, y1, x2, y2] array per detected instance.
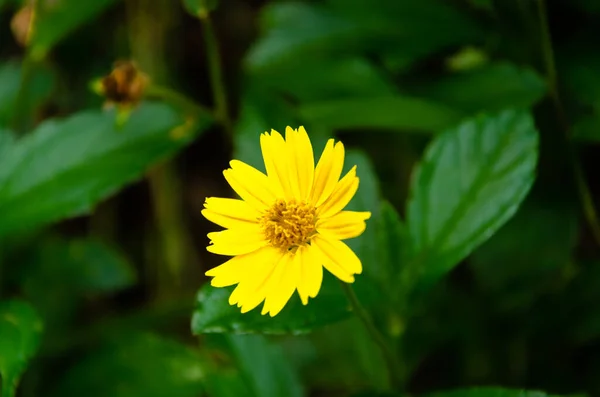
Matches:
[[537, 0, 600, 246]]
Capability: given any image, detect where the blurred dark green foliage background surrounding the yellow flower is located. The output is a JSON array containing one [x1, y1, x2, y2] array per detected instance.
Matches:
[[0, 0, 600, 397]]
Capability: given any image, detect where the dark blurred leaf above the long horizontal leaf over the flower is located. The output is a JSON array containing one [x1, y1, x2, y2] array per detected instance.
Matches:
[[250, 57, 396, 103]]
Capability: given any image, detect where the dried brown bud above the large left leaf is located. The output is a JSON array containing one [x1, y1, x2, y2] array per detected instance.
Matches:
[[100, 61, 148, 107]]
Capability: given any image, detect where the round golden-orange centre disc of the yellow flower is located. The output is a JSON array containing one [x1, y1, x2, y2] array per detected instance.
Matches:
[[260, 200, 317, 249]]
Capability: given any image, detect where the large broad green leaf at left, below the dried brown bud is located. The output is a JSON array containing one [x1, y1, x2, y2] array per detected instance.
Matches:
[[0, 103, 210, 235]]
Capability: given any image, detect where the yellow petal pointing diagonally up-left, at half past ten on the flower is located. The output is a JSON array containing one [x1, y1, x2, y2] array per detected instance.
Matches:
[[223, 160, 276, 211]]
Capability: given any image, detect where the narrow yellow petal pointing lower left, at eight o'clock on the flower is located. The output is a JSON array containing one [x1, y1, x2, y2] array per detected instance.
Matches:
[[205, 246, 277, 287]]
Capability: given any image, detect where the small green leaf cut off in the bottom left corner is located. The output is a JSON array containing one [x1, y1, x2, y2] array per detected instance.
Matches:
[[0, 300, 42, 397]]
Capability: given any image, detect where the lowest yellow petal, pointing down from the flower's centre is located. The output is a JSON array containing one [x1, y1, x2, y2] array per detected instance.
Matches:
[[261, 253, 298, 317]]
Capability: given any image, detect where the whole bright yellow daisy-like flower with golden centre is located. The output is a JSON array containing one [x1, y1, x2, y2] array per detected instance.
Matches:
[[202, 127, 371, 316]]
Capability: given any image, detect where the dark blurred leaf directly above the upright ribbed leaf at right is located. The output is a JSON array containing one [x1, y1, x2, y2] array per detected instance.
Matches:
[[410, 62, 546, 112]]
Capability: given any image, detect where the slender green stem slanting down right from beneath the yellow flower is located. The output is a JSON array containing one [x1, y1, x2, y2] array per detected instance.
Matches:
[[341, 282, 404, 390]]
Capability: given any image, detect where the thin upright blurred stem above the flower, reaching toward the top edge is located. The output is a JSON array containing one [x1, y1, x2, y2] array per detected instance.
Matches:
[[198, 11, 233, 142]]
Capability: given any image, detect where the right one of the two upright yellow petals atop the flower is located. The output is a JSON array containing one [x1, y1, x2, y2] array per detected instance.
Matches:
[[285, 127, 315, 200]]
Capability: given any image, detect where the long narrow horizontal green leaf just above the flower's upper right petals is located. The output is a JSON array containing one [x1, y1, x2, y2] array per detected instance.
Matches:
[[299, 96, 463, 132]]
